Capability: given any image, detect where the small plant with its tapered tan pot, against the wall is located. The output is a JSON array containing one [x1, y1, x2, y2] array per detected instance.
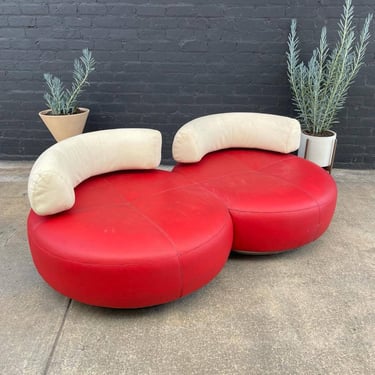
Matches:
[[39, 48, 95, 141]]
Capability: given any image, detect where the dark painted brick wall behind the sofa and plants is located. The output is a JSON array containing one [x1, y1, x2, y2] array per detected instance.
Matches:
[[0, 0, 375, 168]]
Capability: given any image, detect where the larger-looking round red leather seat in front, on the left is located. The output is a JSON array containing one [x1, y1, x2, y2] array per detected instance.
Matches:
[[28, 170, 233, 308]]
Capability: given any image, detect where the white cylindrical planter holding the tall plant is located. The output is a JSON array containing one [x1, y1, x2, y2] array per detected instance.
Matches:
[[298, 130, 336, 167]]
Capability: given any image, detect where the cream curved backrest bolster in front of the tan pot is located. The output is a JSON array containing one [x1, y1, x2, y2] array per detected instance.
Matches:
[[28, 129, 162, 215]]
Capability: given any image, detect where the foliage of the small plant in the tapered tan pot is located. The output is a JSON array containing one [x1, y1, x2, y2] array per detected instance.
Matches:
[[44, 48, 95, 115]]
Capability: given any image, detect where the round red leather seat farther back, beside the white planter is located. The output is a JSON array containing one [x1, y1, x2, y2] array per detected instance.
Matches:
[[173, 149, 337, 253]]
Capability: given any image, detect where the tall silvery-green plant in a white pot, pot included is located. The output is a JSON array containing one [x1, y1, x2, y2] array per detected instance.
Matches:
[[287, 0, 373, 170]]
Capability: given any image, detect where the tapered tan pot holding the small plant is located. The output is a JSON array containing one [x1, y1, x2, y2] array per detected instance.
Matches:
[[39, 108, 90, 142]]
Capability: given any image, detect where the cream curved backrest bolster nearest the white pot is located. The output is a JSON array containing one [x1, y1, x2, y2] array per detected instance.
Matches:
[[172, 112, 301, 163]]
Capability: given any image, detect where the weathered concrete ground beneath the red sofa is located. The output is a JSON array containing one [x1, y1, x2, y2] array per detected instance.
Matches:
[[0, 162, 375, 375]]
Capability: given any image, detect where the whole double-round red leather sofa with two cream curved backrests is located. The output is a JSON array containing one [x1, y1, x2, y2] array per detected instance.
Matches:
[[27, 114, 336, 308]]
